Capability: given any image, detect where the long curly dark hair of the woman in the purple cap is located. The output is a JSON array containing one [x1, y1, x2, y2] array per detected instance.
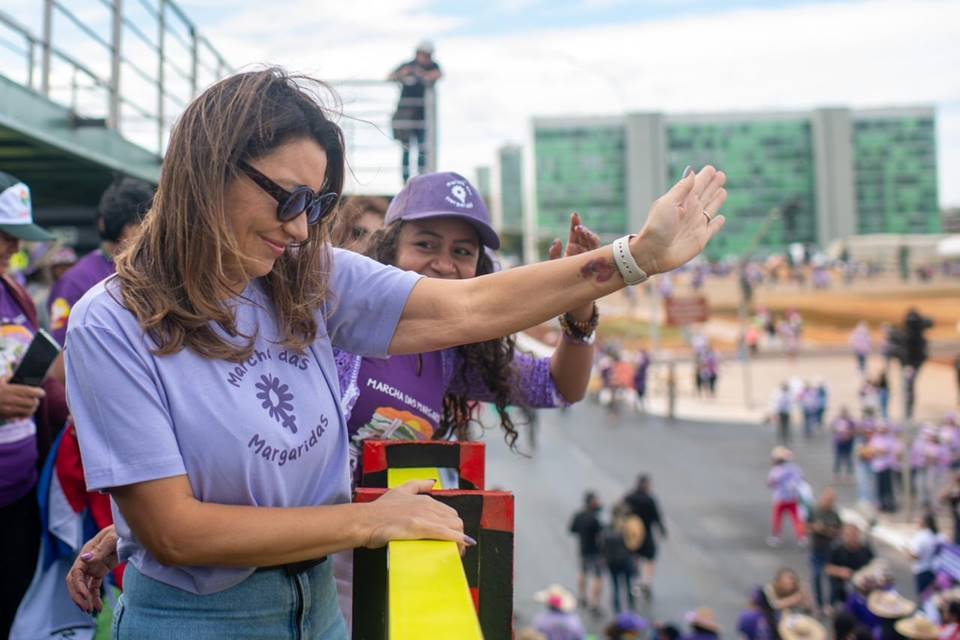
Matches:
[[366, 220, 520, 450]]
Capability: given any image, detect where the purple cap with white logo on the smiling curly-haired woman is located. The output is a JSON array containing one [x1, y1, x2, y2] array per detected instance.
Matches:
[[384, 171, 500, 249]]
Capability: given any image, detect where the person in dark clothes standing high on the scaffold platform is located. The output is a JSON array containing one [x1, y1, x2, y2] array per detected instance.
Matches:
[[387, 40, 443, 184]]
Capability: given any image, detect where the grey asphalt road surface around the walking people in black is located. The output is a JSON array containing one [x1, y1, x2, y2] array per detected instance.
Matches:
[[485, 403, 912, 630]]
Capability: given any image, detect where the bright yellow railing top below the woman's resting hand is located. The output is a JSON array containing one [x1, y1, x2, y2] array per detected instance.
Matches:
[[387, 540, 483, 640]]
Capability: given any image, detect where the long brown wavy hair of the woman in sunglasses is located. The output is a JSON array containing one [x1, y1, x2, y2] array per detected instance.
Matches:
[[117, 67, 344, 362]]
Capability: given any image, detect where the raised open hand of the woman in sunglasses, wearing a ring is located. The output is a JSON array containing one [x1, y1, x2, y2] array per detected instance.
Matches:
[[630, 165, 727, 275]]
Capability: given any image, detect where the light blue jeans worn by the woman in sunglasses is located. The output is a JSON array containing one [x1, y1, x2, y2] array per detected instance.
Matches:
[[113, 560, 349, 640]]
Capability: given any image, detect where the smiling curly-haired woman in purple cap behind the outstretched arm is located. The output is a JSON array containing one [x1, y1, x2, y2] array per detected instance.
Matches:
[[335, 173, 599, 481]]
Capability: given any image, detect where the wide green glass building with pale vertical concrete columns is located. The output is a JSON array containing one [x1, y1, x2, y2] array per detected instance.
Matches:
[[532, 107, 941, 259]]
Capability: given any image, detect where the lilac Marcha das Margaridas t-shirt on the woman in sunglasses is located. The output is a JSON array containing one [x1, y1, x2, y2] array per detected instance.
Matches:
[[67, 250, 420, 594]]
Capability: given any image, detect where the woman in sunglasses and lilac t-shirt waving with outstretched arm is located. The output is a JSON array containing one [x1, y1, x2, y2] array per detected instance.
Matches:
[[66, 69, 726, 639]]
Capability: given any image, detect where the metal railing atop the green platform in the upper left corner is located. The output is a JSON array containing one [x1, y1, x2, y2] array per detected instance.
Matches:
[[0, 0, 233, 155]]
